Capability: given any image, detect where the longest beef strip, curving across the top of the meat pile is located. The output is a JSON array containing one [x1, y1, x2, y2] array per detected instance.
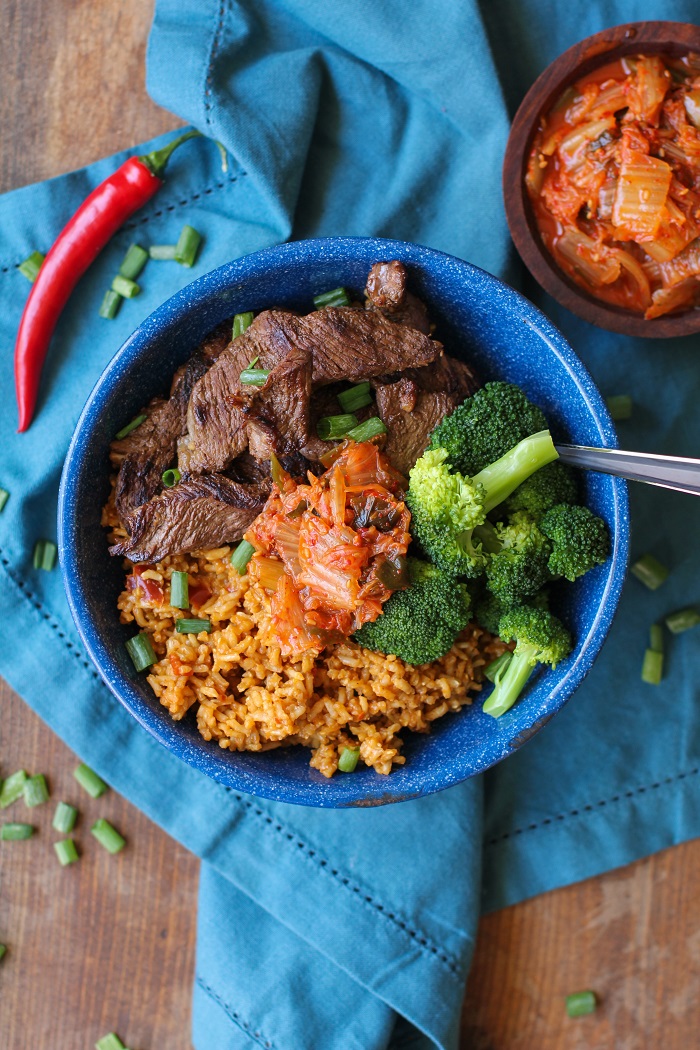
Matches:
[[178, 307, 442, 474]]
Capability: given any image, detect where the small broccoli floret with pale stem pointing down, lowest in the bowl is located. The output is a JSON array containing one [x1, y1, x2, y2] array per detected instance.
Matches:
[[484, 605, 571, 718]]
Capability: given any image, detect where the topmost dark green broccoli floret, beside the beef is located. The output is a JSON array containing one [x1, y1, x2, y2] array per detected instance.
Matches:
[[428, 382, 547, 476]]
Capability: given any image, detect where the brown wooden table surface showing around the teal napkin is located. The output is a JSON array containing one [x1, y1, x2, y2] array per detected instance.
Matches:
[[0, 0, 700, 1050]]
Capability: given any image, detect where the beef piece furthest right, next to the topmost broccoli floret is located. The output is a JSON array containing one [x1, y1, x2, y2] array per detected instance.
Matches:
[[375, 355, 479, 475]]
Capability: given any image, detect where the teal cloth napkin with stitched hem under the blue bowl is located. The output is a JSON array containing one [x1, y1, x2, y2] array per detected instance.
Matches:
[[0, 0, 700, 1050]]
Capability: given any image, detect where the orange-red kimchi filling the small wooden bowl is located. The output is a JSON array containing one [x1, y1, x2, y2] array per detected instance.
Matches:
[[526, 55, 700, 319]]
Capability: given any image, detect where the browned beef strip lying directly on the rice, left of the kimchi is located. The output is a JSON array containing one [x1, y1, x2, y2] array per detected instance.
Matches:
[[109, 475, 271, 563]]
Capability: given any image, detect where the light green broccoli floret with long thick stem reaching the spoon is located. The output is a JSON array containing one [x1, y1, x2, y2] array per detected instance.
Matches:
[[406, 431, 556, 576]]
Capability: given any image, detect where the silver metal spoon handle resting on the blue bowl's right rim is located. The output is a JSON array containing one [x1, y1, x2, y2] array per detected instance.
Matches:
[[555, 445, 700, 496]]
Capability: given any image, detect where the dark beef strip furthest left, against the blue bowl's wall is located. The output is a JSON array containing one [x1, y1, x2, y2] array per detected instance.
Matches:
[[111, 344, 210, 523]]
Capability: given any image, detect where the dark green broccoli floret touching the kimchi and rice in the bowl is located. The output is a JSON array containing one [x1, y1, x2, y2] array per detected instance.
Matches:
[[354, 558, 470, 664]]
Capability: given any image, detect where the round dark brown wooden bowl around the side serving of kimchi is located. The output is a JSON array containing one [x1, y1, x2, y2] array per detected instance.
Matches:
[[503, 22, 700, 339]]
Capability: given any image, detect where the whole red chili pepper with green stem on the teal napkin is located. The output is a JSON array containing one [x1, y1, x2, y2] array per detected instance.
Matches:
[[15, 131, 205, 433]]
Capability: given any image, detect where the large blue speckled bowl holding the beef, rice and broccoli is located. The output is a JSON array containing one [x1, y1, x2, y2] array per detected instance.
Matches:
[[59, 237, 629, 807]]
